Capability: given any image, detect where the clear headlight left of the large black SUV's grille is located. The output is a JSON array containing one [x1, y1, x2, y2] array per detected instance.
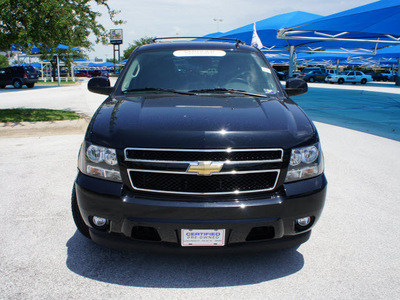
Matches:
[[78, 143, 122, 182]]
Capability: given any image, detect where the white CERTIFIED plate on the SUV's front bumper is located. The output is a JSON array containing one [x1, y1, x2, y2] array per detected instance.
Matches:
[[181, 229, 225, 247]]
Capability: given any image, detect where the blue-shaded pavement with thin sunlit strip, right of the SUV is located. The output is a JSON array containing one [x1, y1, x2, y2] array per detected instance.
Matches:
[[294, 83, 400, 141]]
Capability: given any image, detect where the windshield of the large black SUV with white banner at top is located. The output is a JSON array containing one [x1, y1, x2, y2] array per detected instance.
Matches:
[[121, 50, 279, 96]]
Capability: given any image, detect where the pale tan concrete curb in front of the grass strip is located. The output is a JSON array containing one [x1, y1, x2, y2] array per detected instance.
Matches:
[[0, 118, 90, 138]]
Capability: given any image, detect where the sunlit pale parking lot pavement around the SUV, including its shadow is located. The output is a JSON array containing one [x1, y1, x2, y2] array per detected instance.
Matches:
[[0, 81, 400, 299]]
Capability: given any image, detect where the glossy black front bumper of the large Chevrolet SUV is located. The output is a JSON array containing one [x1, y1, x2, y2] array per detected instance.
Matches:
[[75, 173, 327, 253]]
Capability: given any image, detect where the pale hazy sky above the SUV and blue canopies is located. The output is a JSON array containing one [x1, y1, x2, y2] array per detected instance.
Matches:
[[87, 0, 376, 60]]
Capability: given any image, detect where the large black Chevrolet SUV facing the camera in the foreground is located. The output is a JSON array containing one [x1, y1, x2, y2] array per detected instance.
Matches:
[[72, 40, 327, 253]]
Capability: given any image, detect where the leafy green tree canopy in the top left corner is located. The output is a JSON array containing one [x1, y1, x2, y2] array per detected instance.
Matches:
[[0, 0, 123, 54]]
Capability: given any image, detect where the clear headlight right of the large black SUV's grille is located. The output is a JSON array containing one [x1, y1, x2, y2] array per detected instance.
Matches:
[[285, 143, 324, 182]]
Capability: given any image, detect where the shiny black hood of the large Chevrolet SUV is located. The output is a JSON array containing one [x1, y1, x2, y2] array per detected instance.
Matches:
[[87, 95, 316, 149]]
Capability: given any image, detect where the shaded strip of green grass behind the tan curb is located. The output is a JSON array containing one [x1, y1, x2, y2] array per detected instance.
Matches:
[[0, 108, 80, 123]]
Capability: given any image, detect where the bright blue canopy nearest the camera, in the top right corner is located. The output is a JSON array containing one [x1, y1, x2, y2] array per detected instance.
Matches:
[[278, 0, 400, 48]]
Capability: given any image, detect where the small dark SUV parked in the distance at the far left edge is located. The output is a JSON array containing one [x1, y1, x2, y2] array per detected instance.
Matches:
[[0, 66, 39, 89]]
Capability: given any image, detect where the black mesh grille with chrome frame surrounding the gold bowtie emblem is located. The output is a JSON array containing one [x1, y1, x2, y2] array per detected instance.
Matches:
[[125, 148, 283, 195]]
